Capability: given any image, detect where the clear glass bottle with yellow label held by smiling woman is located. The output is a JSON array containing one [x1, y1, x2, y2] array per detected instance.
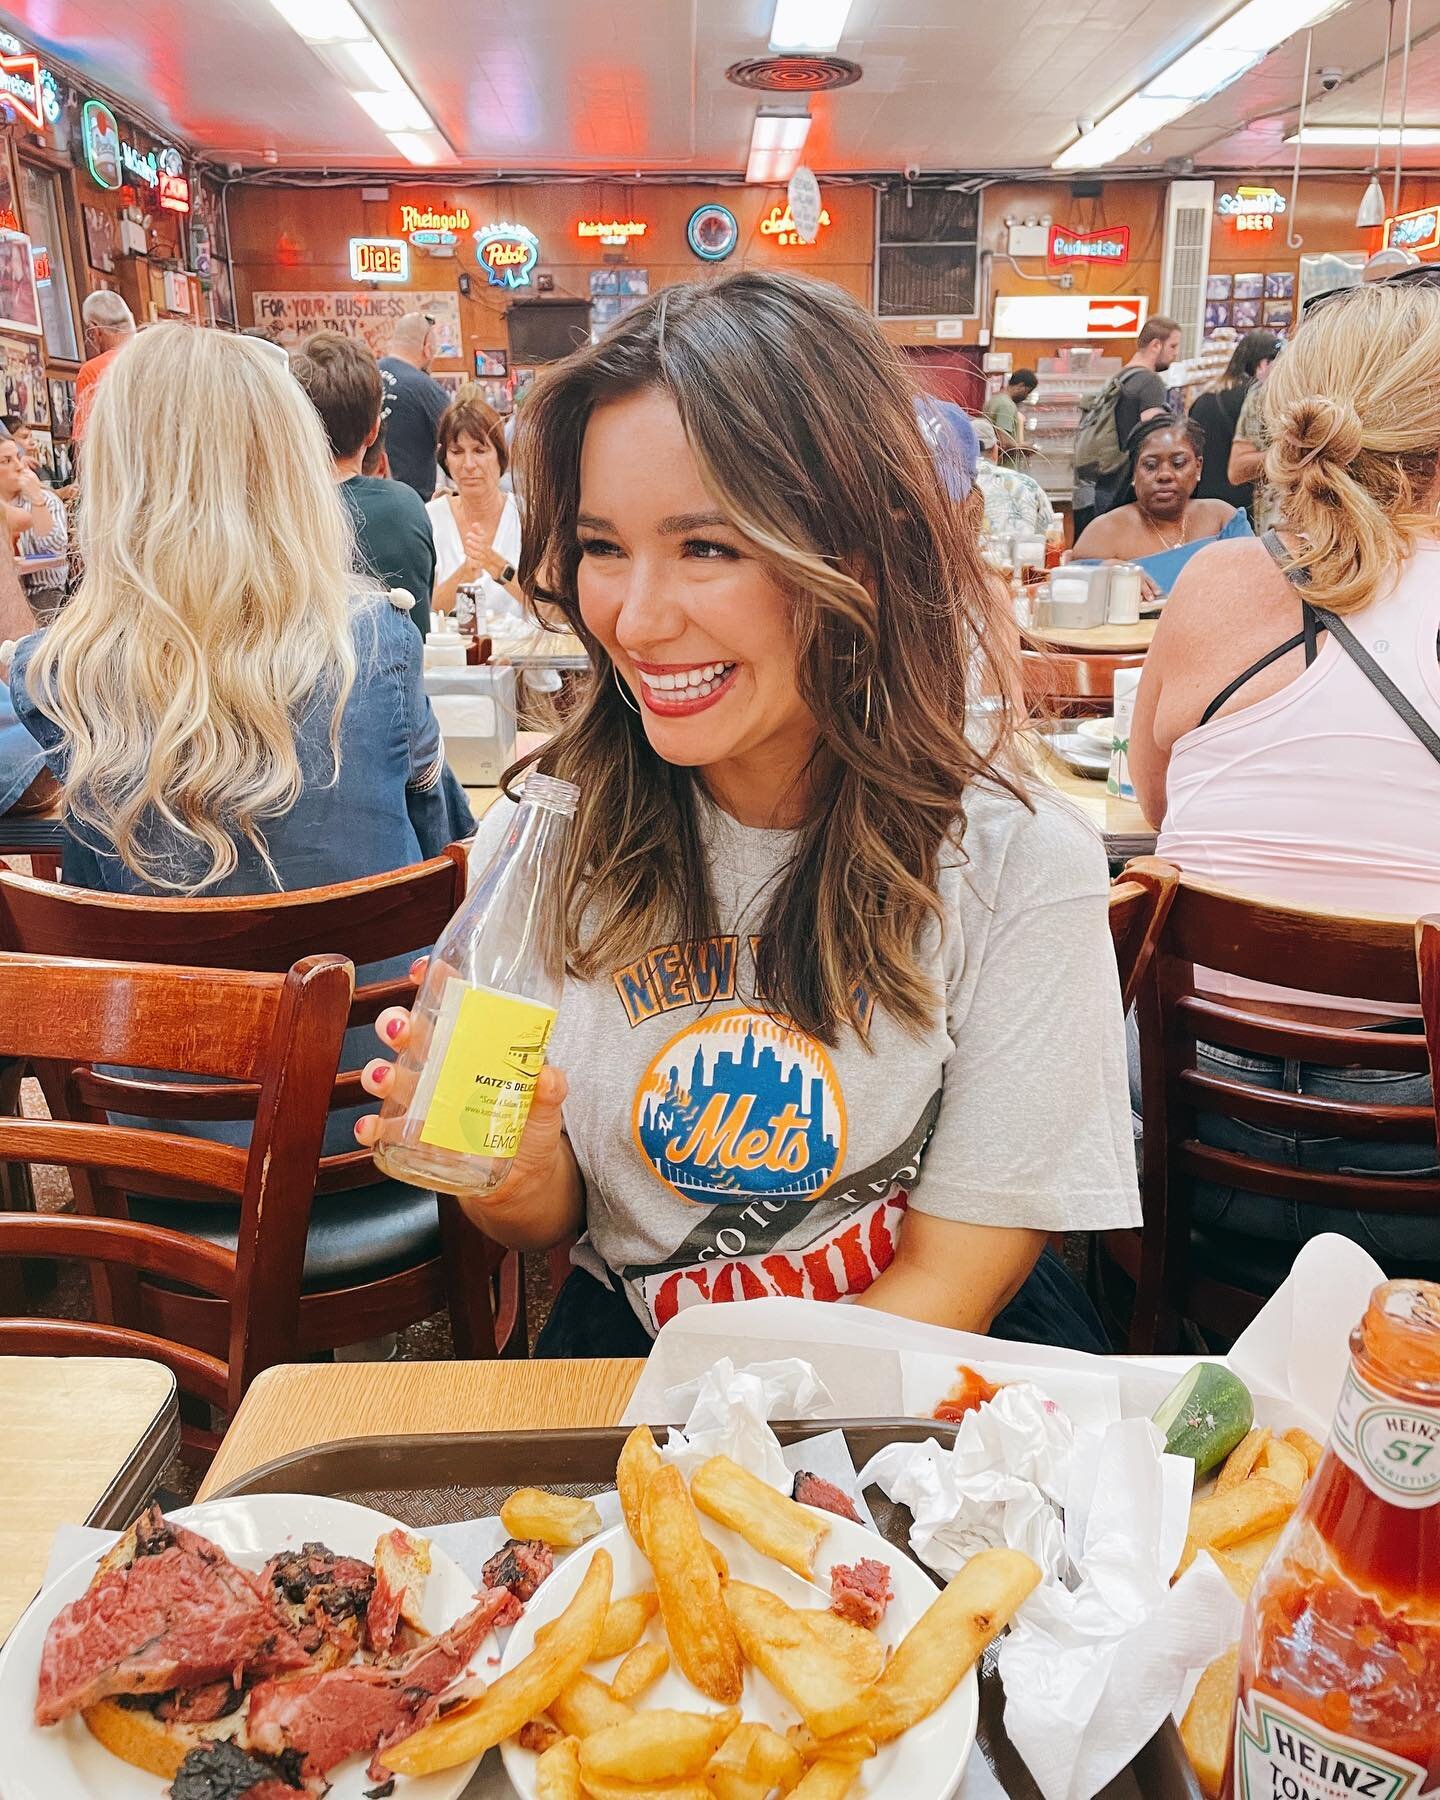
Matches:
[[374, 774, 580, 1193]]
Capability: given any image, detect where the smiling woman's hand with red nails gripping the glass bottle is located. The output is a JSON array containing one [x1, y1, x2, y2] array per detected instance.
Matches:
[[355, 958, 583, 1249]]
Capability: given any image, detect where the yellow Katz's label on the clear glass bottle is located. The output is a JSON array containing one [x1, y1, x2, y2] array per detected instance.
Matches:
[[419, 988, 554, 1157]]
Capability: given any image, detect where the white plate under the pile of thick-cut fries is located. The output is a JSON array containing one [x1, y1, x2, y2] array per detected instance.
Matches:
[[500, 1512, 979, 1800]]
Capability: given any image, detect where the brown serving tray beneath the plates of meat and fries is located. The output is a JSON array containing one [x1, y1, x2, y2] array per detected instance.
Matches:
[[211, 1418, 1202, 1800]]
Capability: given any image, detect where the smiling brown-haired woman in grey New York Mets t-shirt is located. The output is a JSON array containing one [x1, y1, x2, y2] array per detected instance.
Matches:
[[362, 272, 1139, 1355]]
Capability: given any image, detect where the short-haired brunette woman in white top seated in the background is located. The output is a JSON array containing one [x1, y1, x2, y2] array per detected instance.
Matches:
[[425, 385, 524, 630]]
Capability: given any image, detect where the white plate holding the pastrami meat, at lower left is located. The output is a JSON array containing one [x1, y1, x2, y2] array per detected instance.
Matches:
[[0, 1494, 499, 1800]]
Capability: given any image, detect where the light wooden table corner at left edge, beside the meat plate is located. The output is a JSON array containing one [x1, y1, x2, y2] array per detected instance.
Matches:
[[0, 1355, 180, 1642]]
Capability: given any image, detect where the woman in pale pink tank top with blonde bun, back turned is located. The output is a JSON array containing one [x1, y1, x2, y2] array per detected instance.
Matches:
[[1130, 268, 1440, 1269]]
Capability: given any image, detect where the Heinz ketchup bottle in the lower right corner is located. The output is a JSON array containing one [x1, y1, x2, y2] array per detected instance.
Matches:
[[1224, 1282, 1440, 1800]]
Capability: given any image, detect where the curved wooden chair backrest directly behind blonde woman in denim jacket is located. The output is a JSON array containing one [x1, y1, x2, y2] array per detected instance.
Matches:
[[0, 844, 466, 1193]]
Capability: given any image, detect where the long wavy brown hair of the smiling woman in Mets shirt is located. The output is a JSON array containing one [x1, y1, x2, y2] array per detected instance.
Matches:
[[508, 272, 1021, 1042]]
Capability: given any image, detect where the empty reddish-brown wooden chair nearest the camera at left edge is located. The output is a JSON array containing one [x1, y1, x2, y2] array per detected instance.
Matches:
[[0, 952, 353, 1447]]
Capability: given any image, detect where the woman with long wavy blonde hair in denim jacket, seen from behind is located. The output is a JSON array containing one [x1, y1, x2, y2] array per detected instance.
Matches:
[[11, 326, 470, 895]]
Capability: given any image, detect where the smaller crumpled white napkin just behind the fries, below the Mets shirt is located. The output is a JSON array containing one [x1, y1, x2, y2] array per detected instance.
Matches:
[[661, 1355, 833, 1494]]
